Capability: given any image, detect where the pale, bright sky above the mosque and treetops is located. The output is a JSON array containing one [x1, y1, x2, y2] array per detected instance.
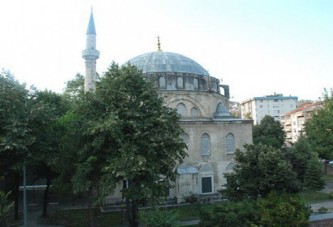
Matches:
[[0, 0, 333, 102]]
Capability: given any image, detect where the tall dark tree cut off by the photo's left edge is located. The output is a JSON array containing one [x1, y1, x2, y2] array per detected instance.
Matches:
[[0, 72, 34, 219]]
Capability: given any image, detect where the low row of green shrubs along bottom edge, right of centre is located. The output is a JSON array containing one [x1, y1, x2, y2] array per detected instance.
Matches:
[[200, 192, 310, 227]]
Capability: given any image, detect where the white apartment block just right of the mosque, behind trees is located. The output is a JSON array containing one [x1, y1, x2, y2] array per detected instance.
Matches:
[[241, 94, 298, 124]]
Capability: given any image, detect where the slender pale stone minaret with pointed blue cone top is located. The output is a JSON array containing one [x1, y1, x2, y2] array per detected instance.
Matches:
[[82, 10, 99, 92]]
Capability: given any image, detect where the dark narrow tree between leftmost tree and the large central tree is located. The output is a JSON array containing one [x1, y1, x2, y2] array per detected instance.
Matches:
[[29, 91, 66, 217]]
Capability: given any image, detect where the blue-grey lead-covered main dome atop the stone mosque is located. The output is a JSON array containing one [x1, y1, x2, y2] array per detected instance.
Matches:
[[128, 51, 208, 76]]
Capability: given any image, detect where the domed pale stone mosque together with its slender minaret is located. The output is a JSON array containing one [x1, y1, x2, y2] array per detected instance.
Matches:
[[82, 13, 252, 203]]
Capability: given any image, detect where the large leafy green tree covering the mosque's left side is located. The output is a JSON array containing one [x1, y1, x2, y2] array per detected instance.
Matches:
[[71, 64, 186, 226]]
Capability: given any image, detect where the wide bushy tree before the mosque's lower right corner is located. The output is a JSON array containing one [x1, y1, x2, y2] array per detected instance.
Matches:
[[222, 144, 300, 200]]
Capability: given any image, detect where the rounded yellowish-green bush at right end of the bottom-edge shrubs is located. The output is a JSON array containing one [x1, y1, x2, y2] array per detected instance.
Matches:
[[258, 192, 310, 227]]
